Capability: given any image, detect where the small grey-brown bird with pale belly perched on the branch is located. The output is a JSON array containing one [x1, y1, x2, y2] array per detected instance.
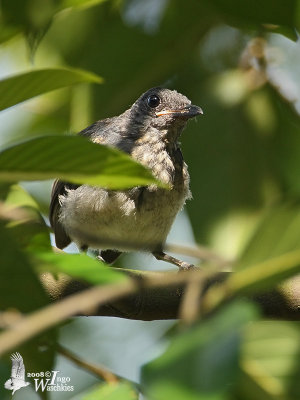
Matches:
[[50, 87, 202, 269]]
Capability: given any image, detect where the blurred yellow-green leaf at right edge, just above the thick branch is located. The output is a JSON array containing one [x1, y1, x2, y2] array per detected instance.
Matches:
[[216, 204, 300, 300]]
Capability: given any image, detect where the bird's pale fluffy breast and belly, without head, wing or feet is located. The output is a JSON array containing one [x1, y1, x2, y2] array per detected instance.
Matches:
[[60, 138, 190, 251]]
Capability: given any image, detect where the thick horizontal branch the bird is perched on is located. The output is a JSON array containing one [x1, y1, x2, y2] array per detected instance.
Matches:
[[42, 270, 300, 321]]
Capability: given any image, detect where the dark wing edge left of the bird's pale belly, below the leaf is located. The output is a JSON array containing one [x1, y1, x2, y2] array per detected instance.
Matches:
[[49, 179, 78, 249]]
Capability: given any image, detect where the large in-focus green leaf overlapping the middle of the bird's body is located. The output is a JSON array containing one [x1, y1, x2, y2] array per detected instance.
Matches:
[[0, 136, 158, 189]]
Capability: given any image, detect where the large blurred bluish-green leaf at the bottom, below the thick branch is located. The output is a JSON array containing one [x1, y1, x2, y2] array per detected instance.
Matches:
[[142, 302, 256, 400]]
